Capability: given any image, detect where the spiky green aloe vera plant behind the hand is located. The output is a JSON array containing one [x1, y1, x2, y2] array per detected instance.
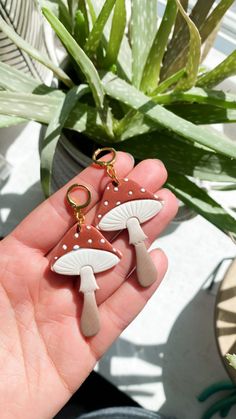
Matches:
[[0, 0, 236, 239]]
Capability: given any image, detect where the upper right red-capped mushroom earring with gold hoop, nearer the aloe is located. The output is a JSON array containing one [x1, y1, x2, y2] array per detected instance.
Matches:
[[92, 147, 163, 287]]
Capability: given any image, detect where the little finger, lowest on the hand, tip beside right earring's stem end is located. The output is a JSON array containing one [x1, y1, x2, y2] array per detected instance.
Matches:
[[90, 250, 168, 359]]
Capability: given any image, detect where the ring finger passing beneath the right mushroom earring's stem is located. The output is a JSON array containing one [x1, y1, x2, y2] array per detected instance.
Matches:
[[96, 189, 178, 304]]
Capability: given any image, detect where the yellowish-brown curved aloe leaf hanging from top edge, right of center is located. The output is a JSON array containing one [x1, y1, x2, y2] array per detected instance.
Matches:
[[175, 0, 201, 90]]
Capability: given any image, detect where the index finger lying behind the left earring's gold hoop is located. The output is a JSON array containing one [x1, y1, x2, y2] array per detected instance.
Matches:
[[9, 152, 134, 253]]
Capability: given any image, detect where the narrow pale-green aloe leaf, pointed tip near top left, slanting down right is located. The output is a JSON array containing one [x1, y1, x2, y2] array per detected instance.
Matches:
[[43, 9, 111, 132]]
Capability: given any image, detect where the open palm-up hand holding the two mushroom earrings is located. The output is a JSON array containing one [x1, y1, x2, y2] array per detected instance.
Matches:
[[0, 152, 177, 419]]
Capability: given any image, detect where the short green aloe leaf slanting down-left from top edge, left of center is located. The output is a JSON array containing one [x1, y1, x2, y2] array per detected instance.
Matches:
[[85, 0, 116, 56]]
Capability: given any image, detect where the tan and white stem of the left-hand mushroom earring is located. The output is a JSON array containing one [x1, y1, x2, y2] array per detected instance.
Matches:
[[79, 266, 100, 337]]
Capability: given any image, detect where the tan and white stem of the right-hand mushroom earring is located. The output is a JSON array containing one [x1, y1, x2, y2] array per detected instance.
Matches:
[[126, 217, 157, 287]]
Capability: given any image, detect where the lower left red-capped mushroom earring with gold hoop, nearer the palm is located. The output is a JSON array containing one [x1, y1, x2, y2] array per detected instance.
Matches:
[[51, 184, 122, 337]]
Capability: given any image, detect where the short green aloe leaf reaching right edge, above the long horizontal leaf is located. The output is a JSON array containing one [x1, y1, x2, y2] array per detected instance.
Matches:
[[197, 50, 236, 88]]
